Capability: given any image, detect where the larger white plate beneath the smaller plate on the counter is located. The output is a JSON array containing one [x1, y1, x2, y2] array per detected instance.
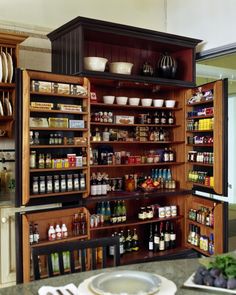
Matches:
[[78, 271, 177, 295]]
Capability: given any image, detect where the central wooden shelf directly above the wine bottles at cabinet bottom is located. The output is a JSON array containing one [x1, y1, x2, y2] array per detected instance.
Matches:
[[90, 215, 183, 231]]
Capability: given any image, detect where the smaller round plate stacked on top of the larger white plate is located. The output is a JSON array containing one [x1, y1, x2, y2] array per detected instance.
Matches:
[[89, 270, 161, 295]]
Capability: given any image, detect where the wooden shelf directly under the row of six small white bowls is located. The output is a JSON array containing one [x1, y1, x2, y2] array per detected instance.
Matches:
[[90, 102, 182, 111]]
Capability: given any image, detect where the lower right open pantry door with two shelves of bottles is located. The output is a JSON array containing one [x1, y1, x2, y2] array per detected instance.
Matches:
[[185, 195, 228, 256]]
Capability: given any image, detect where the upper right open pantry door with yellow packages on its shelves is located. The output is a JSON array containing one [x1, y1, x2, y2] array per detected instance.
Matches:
[[185, 80, 228, 196]]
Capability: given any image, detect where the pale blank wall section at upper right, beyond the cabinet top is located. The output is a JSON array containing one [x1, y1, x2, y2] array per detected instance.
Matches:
[[166, 0, 236, 50]]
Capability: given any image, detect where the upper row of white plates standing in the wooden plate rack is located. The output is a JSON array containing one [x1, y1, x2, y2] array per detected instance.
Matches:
[[0, 48, 13, 83]]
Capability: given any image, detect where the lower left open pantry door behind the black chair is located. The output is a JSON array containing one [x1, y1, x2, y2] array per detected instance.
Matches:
[[17, 207, 90, 283]]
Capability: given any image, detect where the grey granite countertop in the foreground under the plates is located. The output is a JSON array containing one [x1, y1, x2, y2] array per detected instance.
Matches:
[[0, 259, 229, 295]]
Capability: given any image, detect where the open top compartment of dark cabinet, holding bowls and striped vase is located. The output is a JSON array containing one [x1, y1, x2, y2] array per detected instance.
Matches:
[[48, 17, 201, 87]]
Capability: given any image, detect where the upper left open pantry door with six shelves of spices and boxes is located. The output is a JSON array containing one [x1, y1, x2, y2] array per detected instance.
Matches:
[[18, 71, 90, 204]]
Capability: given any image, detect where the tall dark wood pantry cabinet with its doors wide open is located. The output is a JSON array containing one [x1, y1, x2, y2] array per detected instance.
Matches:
[[15, 17, 227, 280]]
